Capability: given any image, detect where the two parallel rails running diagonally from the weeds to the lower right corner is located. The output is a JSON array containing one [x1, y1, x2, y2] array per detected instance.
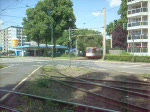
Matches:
[[51, 70, 150, 112]]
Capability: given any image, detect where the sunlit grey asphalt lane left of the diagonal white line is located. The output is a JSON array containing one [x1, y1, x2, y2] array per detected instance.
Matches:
[[0, 59, 40, 99]]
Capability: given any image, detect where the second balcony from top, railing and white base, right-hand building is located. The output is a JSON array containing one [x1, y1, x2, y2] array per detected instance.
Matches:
[[127, 21, 148, 30]]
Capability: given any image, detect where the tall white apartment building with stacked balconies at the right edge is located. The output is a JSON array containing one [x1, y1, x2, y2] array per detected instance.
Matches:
[[127, 0, 150, 56]]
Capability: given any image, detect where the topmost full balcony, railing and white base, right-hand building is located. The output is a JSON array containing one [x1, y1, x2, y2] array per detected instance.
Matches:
[[128, 7, 148, 17]]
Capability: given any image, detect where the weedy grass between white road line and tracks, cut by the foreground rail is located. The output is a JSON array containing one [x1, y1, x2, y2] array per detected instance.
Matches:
[[18, 66, 76, 112]]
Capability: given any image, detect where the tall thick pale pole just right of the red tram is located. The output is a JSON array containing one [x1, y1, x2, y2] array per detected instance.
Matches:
[[103, 8, 106, 60]]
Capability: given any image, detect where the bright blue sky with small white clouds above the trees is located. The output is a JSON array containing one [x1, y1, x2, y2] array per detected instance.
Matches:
[[0, 0, 121, 31]]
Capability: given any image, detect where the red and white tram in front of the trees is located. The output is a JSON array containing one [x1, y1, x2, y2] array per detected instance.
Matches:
[[86, 47, 102, 59]]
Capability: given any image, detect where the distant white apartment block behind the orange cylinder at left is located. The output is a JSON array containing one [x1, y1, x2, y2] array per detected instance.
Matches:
[[0, 26, 26, 52]]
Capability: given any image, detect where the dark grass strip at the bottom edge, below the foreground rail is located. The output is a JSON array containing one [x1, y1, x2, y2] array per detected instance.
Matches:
[[18, 97, 74, 112]]
